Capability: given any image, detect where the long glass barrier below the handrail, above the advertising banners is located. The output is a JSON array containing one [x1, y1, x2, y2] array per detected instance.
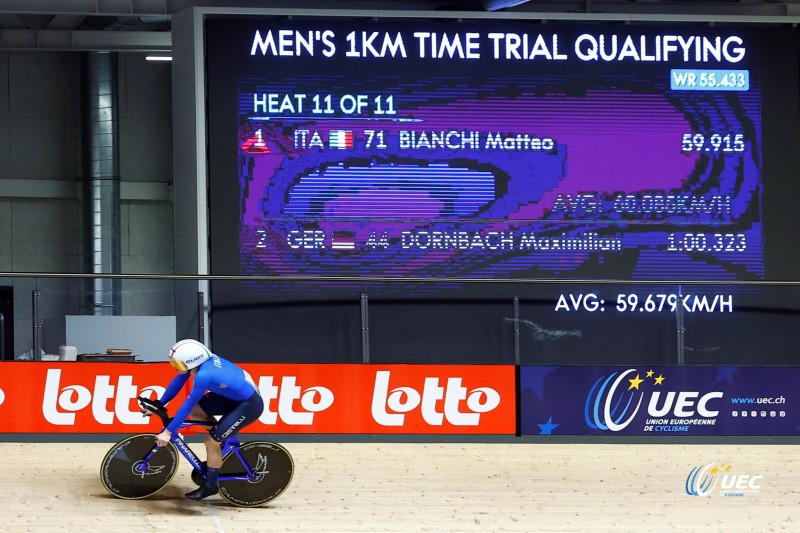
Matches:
[[0, 274, 800, 366]]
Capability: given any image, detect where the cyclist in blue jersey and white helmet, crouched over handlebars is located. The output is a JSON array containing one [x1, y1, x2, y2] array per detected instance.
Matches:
[[144, 339, 264, 500]]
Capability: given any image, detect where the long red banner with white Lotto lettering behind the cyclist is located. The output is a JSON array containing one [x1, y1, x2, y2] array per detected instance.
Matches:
[[0, 362, 516, 434]]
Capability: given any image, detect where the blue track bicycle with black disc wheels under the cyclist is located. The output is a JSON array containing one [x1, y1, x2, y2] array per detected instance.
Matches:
[[100, 396, 294, 507]]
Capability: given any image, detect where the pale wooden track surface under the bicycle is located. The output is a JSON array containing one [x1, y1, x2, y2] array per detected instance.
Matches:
[[0, 443, 800, 533]]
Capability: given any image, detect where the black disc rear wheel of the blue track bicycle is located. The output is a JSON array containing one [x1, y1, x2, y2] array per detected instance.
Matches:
[[219, 441, 294, 507]]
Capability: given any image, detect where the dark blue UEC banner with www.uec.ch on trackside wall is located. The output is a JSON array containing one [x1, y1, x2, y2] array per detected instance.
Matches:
[[520, 366, 800, 436]]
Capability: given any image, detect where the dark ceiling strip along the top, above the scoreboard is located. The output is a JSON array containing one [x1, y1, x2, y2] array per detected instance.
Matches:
[[0, 0, 800, 50]]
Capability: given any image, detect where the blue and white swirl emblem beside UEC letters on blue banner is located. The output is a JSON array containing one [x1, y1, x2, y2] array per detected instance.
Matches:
[[583, 368, 644, 431]]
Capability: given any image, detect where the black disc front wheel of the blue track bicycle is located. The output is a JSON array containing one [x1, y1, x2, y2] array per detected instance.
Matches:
[[100, 433, 178, 500]]
